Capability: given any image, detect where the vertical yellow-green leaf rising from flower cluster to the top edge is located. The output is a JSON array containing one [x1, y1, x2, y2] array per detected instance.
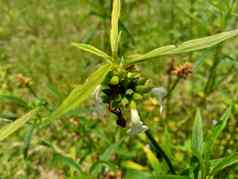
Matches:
[[110, 0, 121, 57]]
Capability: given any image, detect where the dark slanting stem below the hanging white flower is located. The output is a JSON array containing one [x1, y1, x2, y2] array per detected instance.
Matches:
[[145, 130, 176, 174]]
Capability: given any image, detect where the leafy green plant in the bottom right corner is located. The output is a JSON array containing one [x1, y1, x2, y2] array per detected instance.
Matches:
[[188, 107, 238, 179]]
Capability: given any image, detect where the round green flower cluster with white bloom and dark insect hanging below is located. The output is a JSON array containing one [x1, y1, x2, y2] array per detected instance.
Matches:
[[101, 66, 152, 135]]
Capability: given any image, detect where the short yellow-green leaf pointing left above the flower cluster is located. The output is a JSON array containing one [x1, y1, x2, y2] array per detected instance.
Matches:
[[72, 43, 112, 63]]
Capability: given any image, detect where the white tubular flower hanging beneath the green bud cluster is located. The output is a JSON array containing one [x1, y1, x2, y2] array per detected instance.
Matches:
[[127, 109, 148, 136]]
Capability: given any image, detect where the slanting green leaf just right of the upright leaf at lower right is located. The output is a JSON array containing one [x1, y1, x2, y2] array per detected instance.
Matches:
[[206, 107, 232, 154]]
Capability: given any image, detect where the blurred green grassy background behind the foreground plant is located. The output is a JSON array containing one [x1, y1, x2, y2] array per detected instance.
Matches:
[[0, 0, 238, 179]]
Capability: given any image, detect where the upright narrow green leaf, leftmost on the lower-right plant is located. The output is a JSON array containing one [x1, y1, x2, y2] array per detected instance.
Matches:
[[192, 109, 203, 160]]
